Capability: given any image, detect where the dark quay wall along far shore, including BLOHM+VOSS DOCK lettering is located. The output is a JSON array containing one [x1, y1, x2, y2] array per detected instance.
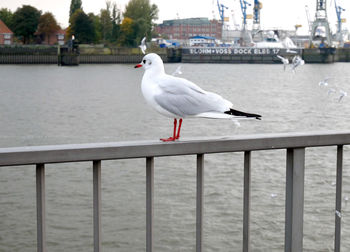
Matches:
[[0, 46, 350, 65]]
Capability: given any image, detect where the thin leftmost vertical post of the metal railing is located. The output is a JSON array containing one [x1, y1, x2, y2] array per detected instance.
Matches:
[[36, 164, 46, 252]]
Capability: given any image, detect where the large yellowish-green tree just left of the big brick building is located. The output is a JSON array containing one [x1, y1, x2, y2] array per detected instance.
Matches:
[[123, 0, 158, 46]]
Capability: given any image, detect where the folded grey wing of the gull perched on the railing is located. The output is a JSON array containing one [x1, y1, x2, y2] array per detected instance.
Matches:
[[155, 76, 232, 117]]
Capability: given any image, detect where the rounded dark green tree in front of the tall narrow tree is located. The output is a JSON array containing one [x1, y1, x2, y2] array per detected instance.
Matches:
[[69, 9, 96, 43]]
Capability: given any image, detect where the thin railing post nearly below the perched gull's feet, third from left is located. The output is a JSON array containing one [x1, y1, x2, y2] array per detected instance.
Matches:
[[146, 157, 154, 252]]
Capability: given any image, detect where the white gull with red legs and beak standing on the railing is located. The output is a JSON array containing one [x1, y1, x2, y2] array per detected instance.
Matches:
[[135, 53, 261, 142]]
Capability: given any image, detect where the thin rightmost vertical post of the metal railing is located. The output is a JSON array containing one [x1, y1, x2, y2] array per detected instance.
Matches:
[[334, 145, 343, 252]]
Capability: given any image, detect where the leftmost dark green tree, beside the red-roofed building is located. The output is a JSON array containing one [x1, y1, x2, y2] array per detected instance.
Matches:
[[13, 5, 41, 44]]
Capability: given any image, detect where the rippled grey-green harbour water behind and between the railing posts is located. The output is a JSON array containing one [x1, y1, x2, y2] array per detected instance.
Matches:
[[0, 63, 350, 252]]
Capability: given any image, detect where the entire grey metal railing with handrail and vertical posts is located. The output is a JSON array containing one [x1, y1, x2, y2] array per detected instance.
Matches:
[[0, 132, 350, 252]]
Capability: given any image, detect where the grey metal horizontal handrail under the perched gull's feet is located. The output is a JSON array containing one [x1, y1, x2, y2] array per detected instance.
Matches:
[[0, 131, 350, 166]]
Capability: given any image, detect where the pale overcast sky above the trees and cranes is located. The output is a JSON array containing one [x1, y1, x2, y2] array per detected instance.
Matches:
[[0, 0, 350, 33]]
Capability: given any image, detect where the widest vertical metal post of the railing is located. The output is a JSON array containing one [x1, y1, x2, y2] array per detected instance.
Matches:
[[284, 148, 305, 252]]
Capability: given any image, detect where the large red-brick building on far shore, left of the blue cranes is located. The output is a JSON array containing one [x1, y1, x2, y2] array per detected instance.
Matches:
[[155, 18, 222, 40]]
